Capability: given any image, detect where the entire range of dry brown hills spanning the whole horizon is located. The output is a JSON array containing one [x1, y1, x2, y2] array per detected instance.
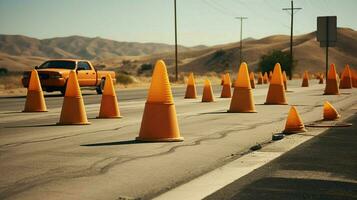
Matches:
[[0, 28, 357, 74]]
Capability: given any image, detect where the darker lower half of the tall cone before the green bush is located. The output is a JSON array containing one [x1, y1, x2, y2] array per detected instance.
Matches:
[[264, 84, 288, 105]]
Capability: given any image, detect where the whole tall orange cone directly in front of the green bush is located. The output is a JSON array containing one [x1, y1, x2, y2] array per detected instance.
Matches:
[[265, 63, 288, 105]]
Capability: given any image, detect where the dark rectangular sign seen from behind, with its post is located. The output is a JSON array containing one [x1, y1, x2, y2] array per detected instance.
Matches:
[[316, 16, 337, 77]]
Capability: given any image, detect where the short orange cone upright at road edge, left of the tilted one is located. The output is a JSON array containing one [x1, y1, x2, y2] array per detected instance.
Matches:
[[283, 106, 306, 134]]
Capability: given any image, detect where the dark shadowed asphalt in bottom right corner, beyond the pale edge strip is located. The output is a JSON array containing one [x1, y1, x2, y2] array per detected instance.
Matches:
[[205, 106, 357, 200]]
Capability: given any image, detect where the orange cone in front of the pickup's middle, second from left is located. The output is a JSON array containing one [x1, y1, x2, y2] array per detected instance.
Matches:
[[57, 71, 90, 125]]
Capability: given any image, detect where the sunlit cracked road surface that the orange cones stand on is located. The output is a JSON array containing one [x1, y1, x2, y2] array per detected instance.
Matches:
[[0, 80, 357, 199]]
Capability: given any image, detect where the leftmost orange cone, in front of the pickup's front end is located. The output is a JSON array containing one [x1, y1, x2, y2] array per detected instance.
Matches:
[[23, 70, 47, 112]]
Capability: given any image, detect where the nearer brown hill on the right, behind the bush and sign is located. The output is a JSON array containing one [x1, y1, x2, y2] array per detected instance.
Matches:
[[181, 28, 357, 73]]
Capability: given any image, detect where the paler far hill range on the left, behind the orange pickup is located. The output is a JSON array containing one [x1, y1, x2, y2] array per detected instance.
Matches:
[[0, 35, 206, 70]]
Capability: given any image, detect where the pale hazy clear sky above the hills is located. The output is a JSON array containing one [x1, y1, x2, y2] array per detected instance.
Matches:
[[0, 0, 357, 46]]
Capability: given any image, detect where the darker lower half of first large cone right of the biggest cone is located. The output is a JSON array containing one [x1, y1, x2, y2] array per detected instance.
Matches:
[[227, 87, 256, 113]]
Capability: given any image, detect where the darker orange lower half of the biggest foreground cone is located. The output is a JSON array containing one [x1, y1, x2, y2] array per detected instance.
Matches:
[[136, 102, 184, 142]]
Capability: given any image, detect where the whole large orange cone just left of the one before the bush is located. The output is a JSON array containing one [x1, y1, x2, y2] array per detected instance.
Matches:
[[228, 62, 256, 113]]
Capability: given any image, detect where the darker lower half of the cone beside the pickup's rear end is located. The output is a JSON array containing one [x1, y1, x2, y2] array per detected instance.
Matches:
[[97, 95, 123, 119]]
